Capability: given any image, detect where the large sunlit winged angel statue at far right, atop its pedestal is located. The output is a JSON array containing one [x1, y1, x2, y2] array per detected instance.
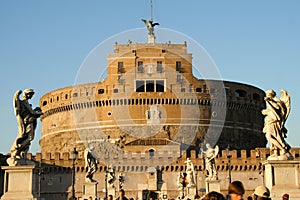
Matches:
[[262, 90, 294, 160]]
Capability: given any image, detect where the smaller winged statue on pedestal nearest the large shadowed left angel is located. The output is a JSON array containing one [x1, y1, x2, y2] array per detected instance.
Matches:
[[84, 147, 98, 182]]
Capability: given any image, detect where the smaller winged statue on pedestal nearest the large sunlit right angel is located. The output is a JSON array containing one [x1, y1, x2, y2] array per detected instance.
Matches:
[[201, 143, 219, 180]]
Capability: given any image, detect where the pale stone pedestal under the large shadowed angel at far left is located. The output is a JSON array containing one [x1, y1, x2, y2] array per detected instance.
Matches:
[[1, 165, 39, 200]]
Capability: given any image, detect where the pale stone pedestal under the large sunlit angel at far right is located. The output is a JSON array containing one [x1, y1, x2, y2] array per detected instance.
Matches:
[[263, 160, 300, 200]]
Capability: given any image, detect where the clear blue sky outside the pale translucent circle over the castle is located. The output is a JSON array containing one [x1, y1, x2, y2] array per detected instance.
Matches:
[[0, 0, 300, 153]]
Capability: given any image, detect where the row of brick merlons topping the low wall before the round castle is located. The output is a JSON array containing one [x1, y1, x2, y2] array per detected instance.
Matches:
[[24, 148, 294, 168]]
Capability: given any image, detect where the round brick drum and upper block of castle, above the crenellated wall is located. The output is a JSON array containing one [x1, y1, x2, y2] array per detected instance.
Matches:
[[40, 41, 266, 154]]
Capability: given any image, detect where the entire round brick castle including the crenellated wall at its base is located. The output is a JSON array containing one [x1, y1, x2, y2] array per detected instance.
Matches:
[[1, 19, 300, 200]]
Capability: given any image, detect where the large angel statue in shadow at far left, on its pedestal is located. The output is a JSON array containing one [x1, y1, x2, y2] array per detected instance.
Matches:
[[7, 89, 43, 166]]
